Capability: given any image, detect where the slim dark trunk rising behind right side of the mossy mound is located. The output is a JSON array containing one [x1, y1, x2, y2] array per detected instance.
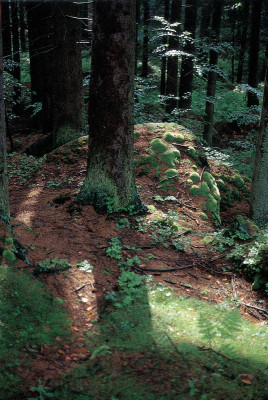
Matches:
[[203, 0, 222, 145]]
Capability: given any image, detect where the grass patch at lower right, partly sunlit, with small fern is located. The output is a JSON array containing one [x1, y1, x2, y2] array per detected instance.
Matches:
[[54, 276, 268, 400]]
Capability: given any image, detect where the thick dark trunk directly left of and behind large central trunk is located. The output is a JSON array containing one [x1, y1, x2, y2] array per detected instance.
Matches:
[[49, 1, 84, 148]]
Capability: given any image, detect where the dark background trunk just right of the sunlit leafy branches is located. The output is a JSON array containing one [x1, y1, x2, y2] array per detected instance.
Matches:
[[179, 0, 197, 110]]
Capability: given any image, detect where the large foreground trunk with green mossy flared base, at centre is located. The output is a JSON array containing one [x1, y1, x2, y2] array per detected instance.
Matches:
[[77, 0, 146, 216]]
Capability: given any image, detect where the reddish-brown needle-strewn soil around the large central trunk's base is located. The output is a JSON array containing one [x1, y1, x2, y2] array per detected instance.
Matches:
[[2, 127, 265, 396]]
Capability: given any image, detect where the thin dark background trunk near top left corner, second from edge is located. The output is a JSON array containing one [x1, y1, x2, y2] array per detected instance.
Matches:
[[11, 1, 21, 108]]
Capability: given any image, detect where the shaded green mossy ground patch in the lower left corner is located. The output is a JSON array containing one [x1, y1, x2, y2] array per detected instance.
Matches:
[[0, 266, 68, 400]]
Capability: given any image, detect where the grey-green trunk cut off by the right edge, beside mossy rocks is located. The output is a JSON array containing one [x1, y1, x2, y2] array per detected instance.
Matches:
[[251, 63, 268, 226]]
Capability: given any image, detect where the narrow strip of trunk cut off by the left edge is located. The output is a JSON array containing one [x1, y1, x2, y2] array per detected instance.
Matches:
[[0, 1, 9, 219]]
